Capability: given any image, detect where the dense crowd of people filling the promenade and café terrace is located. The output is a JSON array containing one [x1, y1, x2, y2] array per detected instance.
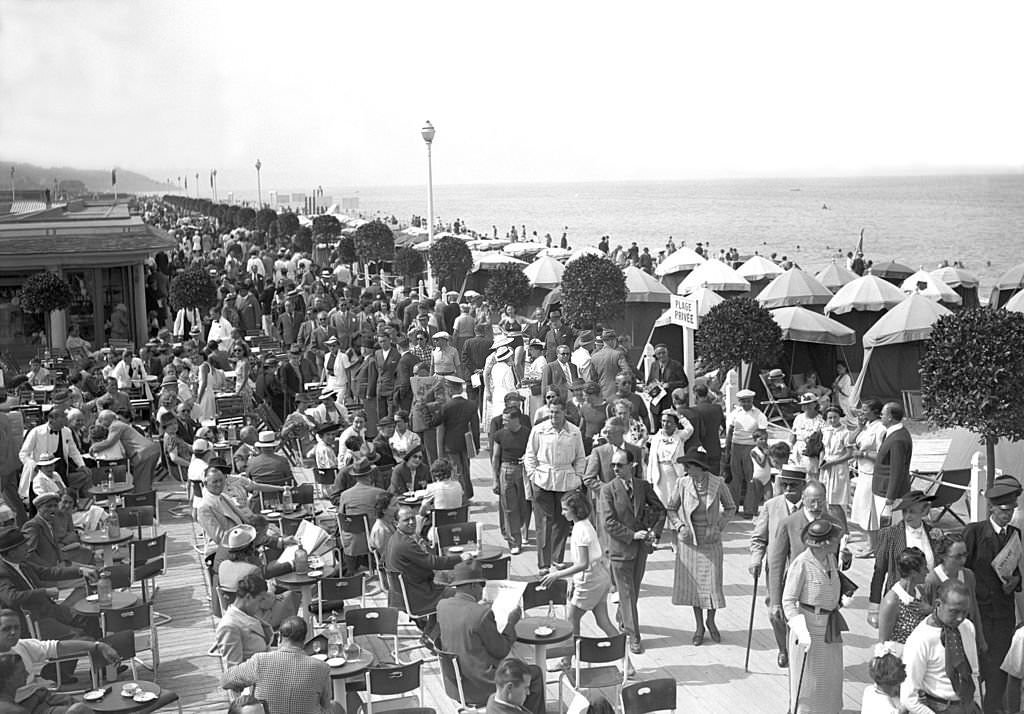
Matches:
[[0, 194, 1024, 714]]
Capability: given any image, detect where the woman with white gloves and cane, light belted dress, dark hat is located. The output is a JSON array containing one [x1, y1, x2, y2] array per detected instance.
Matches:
[[782, 518, 846, 714]]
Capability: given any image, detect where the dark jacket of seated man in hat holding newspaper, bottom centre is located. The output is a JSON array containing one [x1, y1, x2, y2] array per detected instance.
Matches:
[[437, 592, 515, 706]]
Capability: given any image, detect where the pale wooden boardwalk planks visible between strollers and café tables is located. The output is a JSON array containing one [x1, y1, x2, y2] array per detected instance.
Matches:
[[134, 434, 963, 714]]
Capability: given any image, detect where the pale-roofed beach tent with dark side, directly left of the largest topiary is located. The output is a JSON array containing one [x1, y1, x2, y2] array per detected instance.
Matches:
[[850, 293, 952, 404]]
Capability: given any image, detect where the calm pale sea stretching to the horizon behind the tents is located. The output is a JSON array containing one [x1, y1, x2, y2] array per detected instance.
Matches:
[[264, 173, 1024, 296]]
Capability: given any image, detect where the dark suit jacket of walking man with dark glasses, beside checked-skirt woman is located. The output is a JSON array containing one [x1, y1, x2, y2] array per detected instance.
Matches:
[[598, 476, 665, 560]]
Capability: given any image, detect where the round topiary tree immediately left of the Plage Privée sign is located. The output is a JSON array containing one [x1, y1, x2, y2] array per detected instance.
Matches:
[[557, 255, 627, 330]]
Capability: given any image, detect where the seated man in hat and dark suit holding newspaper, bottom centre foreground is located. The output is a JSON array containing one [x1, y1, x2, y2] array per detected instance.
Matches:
[[437, 560, 544, 712]]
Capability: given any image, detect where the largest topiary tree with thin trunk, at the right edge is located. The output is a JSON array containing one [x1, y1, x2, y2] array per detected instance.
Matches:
[[920, 307, 1024, 486]]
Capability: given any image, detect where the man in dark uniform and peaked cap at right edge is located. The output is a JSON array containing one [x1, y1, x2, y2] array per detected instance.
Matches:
[[964, 476, 1021, 714]]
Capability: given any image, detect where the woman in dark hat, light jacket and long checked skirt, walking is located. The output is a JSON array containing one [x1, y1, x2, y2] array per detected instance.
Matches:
[[667, 452, 736, 645]]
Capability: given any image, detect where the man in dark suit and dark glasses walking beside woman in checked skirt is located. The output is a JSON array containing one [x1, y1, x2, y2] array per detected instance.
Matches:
[[599, 450, 665, 655]]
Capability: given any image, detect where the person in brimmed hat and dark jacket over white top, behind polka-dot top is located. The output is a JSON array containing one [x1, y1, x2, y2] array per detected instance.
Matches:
[[867, 491, 938, 627]]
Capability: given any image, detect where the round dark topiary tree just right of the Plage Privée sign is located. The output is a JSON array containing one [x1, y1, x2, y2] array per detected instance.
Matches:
[[693, 297, 782, 385]]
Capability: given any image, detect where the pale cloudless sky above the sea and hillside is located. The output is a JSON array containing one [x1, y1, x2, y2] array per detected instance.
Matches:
[[0, 0, 1024, 190]]
